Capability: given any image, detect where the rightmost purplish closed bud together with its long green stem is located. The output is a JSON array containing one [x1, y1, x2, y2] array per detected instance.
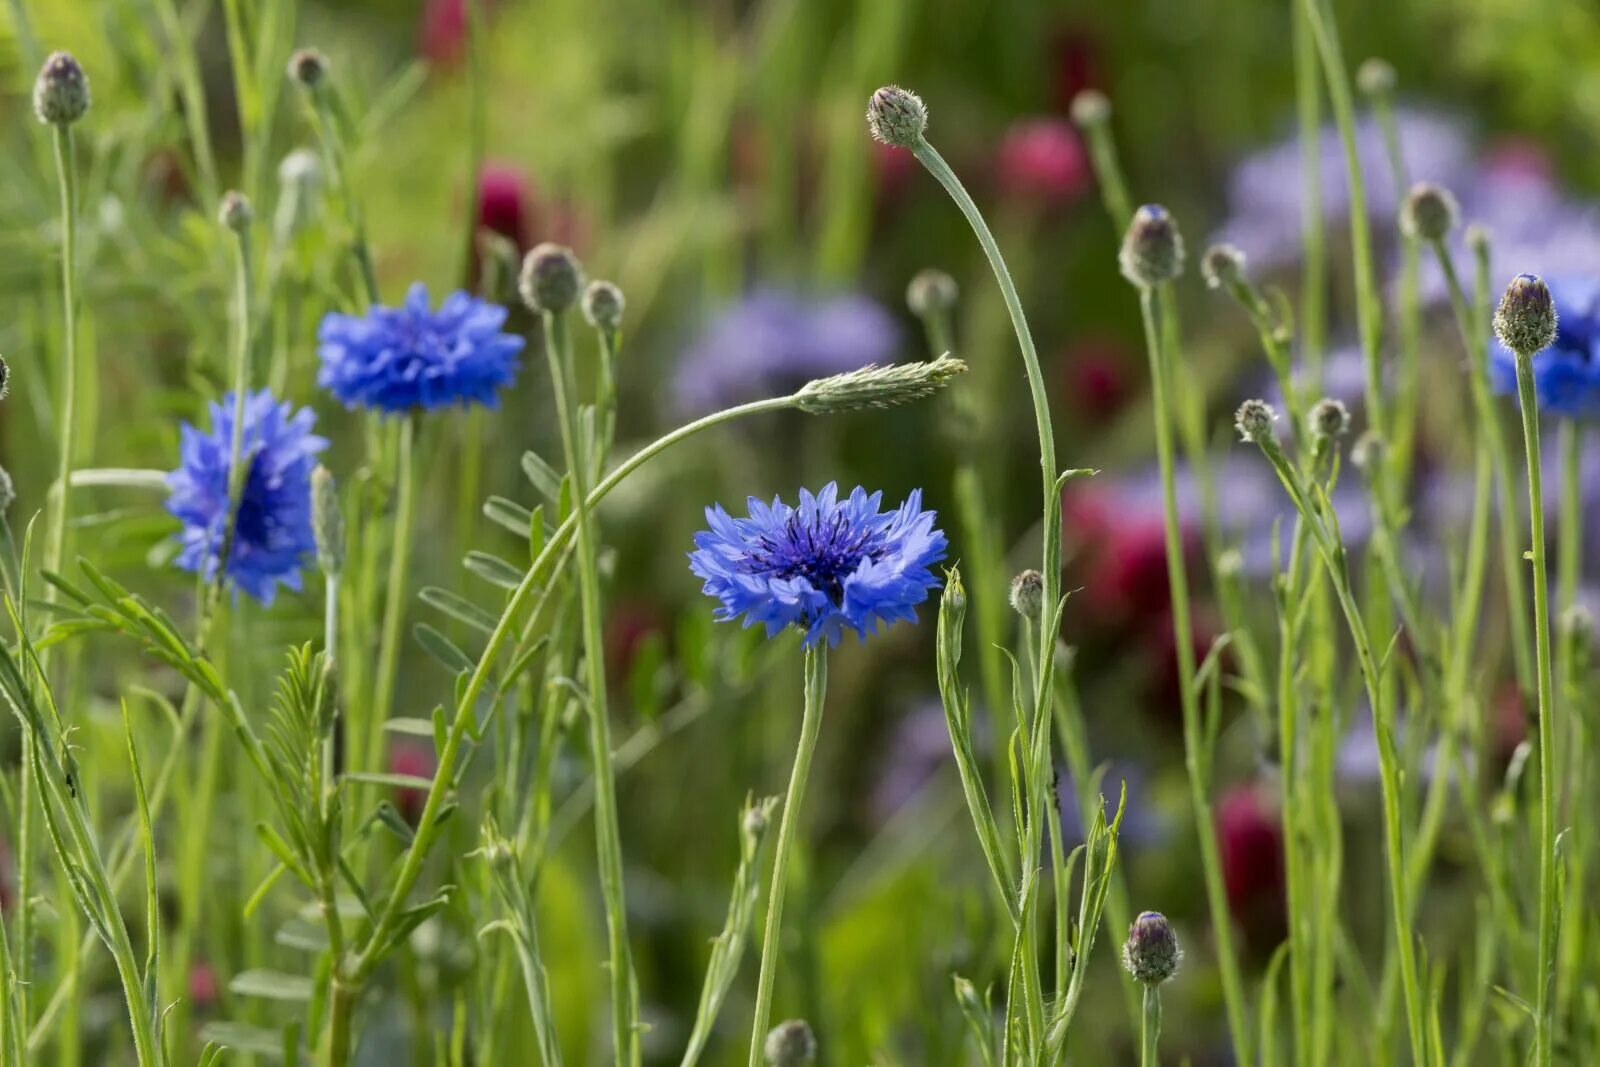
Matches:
[[1494, 274, 1558, 1067]]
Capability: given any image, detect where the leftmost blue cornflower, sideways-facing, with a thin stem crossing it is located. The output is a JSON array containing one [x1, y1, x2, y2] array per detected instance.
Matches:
[[166, 389, 328, 605]]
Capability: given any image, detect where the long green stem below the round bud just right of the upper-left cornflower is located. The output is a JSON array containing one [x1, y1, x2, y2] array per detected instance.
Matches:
[[544, 312, 640, 1065]]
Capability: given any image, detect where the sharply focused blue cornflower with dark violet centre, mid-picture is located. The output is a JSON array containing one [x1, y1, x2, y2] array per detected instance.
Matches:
[[690, 482, 947, 645]]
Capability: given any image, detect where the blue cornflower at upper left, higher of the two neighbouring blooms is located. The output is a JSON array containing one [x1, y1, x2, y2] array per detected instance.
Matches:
[[317, 282, 523, 413]]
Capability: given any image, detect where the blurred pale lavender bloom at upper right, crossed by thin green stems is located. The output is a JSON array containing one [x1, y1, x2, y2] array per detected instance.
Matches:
[[1216, 107, 1472, 269]]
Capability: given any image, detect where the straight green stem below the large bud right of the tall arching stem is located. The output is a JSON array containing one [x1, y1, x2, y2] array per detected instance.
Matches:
[[1139, 288, 1254, 1064]]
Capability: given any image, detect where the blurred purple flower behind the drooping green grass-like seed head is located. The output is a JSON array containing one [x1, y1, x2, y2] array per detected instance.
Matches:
[[672, 290, 899, 414]]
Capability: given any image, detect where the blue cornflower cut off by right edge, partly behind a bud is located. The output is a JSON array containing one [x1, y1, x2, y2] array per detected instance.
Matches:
[[1490, 277, 1600, 419]]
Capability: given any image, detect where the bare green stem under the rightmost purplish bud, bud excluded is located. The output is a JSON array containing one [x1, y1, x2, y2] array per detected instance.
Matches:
[[1515, 352, 1557, 1067]]
